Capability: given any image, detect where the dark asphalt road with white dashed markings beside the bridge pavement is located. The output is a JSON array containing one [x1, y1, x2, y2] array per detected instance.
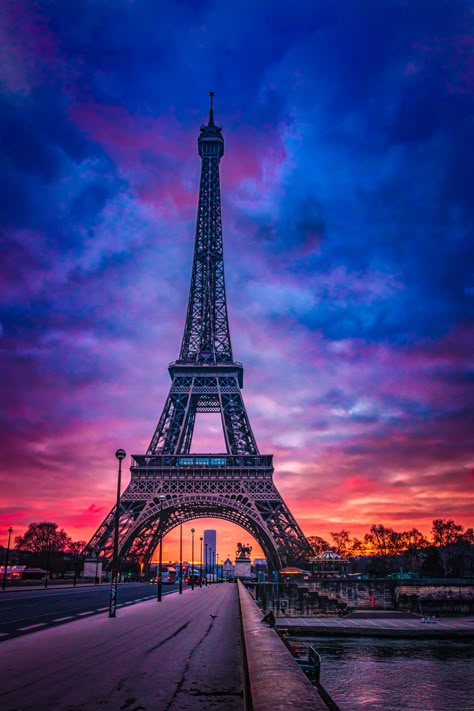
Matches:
[[0, 583, 181, 642]]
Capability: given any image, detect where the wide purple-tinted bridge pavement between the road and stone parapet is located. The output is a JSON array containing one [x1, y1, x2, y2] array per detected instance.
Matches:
[[0, 585, 243, 711]]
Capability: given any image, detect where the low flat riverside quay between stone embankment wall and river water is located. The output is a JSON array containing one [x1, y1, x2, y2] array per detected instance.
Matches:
[[276, 613, 474, 639]]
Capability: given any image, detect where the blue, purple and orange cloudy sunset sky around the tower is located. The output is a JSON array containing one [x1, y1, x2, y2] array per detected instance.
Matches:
[[0, 0, 474, 558]]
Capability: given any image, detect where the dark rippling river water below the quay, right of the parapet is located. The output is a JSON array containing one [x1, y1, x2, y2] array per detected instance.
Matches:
[[295, 637, 474, 711]]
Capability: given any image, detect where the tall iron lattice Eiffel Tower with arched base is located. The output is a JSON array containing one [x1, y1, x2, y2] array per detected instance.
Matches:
[[85, 92, 312, 570]]
